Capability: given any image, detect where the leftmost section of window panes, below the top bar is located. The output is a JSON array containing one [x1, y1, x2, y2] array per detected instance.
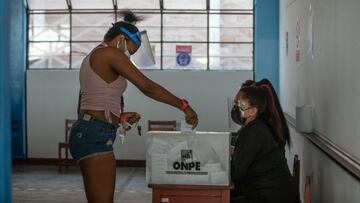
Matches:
[[28, 14, 70, 69]]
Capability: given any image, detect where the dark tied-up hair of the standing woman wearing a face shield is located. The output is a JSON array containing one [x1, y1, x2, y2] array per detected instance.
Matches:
[[104, 10, 142, 42]]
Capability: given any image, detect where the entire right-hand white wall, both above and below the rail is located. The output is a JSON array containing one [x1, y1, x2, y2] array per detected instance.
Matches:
[[280, 0, 360, 203]]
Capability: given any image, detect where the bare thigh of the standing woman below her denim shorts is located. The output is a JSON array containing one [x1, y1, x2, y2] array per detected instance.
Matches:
[[79, 153, 116, 203]]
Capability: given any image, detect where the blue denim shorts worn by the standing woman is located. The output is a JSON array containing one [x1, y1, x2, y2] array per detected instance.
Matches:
[[69, 113, 117, 162]]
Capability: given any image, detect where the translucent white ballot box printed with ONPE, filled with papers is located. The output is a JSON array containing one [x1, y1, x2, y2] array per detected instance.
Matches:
[[146, 131, 230, 186]]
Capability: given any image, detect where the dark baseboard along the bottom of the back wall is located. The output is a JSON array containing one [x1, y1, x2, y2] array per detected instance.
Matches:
[[13, 158, 146, 167]]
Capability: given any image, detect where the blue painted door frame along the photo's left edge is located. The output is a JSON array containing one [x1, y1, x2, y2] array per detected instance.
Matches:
[[0, 0, 26, 203]]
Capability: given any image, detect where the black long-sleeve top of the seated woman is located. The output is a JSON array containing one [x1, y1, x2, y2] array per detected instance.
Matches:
[[231, 120, 299, 203]]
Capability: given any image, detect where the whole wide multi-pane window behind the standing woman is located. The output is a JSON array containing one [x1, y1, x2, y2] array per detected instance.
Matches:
[[27, 0, 254, 70]]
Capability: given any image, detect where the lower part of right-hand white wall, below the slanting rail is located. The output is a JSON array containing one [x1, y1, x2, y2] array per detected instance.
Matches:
[[287, 127, 360, 203]]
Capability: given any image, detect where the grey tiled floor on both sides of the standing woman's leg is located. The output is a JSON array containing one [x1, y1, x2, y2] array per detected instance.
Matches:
[[12, 165, 151, 203]]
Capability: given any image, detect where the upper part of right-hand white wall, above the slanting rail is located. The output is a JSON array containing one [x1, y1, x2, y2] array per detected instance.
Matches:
[[280, 0, 360, 157]]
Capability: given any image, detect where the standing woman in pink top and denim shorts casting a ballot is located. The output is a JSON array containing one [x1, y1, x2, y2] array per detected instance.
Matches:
[[69, 11, 198, 203]]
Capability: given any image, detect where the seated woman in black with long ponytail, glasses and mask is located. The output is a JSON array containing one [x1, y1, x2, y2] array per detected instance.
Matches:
[[231, 85, 299, 203]]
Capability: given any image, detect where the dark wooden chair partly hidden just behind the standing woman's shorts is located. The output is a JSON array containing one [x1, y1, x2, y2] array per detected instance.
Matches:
[[58, 119, 76, 173]]
